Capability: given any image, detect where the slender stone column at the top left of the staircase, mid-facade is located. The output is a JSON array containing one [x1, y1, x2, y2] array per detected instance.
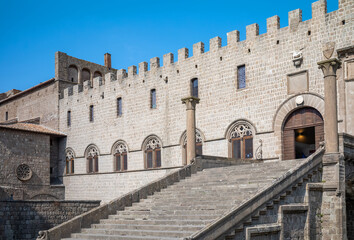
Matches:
[[182, 97, 199, 165]]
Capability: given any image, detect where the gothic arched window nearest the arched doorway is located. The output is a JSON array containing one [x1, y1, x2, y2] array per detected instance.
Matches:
[[228, 121, 254, 159]]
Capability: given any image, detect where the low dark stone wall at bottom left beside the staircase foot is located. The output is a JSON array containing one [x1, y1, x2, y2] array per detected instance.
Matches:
[[0, 201, 100, 240]]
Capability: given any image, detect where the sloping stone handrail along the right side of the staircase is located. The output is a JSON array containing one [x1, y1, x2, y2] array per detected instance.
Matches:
[[185, 146, 324, 240]]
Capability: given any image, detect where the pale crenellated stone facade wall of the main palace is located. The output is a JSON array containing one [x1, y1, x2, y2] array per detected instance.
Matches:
[[59, 0, 354, 178]]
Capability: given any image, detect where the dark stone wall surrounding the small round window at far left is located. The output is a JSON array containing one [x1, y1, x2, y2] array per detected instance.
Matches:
[[0, 128, 64, 199]]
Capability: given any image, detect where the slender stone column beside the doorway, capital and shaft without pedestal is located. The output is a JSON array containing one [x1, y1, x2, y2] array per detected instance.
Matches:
[[317, 58, 341, 153]]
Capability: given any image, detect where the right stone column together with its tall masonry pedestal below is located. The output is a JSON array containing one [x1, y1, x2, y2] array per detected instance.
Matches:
[[318, 58, 346, 240]]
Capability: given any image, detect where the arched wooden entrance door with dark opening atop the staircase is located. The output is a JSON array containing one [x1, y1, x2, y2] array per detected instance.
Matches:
[[282, 107, 324, 160]]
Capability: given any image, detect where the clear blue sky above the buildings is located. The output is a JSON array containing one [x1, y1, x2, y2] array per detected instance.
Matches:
[[0, 0, 338, 93]]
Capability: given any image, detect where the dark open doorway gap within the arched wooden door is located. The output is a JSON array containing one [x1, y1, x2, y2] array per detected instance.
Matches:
[[294, 127, 316, 158]]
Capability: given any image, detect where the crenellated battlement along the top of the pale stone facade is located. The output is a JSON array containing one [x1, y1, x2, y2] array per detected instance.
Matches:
[[58, 0, 353, 101]]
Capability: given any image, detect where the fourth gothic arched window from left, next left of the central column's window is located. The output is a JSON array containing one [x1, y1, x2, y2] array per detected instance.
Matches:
[[144, 137, 162, 168]]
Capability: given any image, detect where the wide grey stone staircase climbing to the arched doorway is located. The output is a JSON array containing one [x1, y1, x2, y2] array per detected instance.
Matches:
[[60, 160, 307, 240]]
